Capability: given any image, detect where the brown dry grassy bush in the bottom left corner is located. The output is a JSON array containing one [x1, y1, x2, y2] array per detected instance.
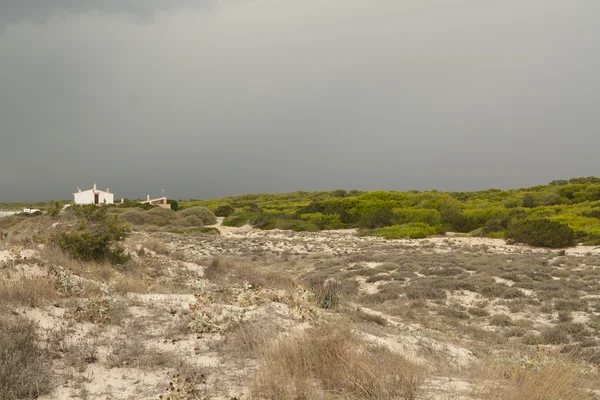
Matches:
[[0, 316, 54, 400]]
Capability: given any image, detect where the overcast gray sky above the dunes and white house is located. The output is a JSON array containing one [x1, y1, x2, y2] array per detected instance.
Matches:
[[0, 0, 600, 201]]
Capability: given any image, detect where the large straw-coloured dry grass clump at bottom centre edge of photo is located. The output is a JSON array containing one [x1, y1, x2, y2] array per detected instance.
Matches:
[[251, 325, 424, 399]]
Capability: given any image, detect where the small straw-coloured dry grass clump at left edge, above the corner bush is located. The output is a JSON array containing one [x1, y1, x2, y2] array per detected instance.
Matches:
[[0, 276, 57, 307]]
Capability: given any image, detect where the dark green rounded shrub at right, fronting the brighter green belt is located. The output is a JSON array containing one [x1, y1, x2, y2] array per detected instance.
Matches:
[[506, 217, 575, 248]]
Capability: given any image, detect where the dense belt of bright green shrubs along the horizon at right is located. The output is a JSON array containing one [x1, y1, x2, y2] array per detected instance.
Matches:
[[180, 177, 600, 247]]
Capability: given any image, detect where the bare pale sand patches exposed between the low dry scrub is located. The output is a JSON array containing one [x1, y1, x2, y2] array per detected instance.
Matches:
[[0, 219, 600, 400]]
